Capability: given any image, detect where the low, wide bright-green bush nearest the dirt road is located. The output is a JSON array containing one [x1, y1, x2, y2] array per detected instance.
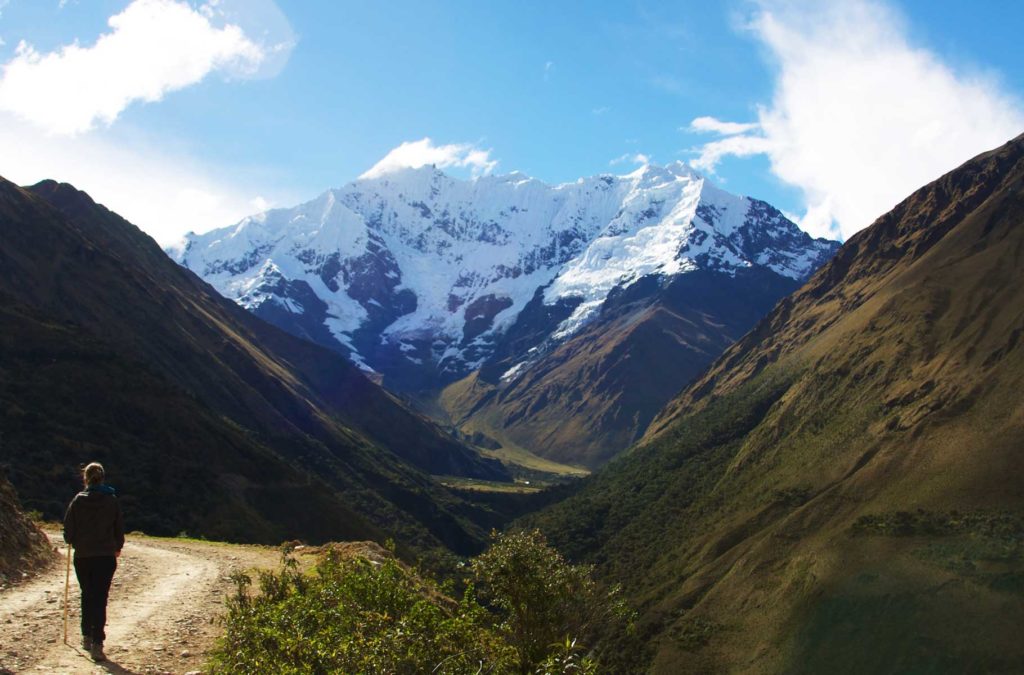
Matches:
[[212, 551, 512, 675]]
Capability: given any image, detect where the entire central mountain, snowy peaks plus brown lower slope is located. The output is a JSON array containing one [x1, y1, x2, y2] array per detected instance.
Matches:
[[177, 162, 838, 468]]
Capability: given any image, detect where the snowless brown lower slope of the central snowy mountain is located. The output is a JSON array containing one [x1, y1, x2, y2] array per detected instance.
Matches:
[[440, 268, 797, 469]]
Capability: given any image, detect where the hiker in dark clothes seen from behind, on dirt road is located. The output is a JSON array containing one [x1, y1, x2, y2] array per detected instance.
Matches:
[[65, 462, 125, 661]]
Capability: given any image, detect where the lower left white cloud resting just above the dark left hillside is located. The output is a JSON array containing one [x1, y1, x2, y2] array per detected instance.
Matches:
[[0, 115, 298, 246]]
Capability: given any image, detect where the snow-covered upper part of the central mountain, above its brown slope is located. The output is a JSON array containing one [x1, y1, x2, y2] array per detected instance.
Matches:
[[176, 163, 838, 388]]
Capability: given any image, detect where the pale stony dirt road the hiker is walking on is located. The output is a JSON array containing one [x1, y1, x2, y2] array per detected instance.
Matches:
[[0, 536, 280, 675]]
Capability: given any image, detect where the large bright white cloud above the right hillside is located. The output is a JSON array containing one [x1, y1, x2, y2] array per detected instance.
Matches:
[[690, 0, 1024, 238]]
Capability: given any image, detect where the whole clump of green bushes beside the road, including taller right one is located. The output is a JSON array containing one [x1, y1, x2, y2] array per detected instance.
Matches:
[[211, 532, 629, 675]]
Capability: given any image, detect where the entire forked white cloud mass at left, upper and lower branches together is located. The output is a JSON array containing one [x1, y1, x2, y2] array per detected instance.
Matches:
[[0, 0, 301, 246]]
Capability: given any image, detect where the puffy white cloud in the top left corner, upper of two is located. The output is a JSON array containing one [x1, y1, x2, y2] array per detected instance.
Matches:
[[0, 0, 280, 134]]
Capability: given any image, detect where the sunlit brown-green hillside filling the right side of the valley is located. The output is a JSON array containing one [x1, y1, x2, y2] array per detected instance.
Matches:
[[536, 138, 1024, 673]]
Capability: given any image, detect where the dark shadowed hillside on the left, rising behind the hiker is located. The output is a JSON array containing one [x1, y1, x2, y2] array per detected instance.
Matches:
[[0, 177, 505, 551]]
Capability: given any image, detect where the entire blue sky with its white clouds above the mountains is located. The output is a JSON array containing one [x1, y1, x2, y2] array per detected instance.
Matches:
[[0, 0, 1024, 244]]
